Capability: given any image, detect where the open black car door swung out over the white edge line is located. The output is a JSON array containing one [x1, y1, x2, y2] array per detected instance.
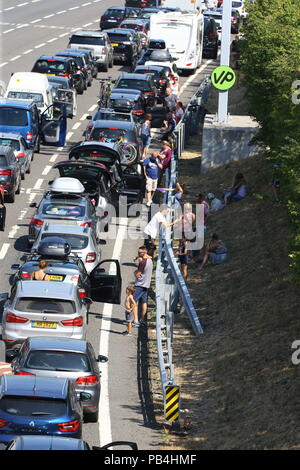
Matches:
[[90, 259, 122, 304]]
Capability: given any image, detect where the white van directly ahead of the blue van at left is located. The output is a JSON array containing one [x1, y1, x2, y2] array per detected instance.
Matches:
[[5, 72, 53, 113]]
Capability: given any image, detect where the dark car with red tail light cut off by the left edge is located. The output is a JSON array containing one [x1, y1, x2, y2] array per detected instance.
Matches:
[[0, 145, 21, 202]]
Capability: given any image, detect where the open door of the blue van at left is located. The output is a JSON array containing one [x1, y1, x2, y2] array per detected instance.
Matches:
[[40, 101, 67, 147]]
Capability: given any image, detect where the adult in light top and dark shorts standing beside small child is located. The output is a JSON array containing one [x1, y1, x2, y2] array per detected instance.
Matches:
[[133, 246, 153, 326]]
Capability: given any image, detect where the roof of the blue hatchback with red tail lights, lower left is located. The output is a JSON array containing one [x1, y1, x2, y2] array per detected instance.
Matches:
[[0, 374, 69, 399]]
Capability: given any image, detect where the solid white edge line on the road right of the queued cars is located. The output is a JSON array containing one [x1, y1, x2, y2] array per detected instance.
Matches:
[[99, 217, 128, 446]]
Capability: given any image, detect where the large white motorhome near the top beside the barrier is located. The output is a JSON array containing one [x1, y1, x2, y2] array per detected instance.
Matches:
[[150, 11, 204, 73]]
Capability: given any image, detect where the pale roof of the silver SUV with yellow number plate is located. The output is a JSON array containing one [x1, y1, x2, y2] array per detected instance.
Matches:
[[16, 281, 77, 300]]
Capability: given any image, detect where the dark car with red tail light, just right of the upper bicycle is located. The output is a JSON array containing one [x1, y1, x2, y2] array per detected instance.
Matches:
[[109, 88, 147, 118]]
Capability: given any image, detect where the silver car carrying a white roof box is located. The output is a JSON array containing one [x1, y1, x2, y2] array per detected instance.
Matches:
[[28, 178, 104, 245]]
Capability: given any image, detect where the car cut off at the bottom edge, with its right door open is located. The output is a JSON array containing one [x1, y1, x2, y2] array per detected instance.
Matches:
[[3, 436, 138, 451]]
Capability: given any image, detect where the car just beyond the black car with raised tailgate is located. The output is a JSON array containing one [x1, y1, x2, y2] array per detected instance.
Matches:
[[87, 121, 142, 161]]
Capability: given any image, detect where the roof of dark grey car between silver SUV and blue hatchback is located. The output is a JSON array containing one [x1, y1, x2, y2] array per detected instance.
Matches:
[[28, 336, 88, 353]]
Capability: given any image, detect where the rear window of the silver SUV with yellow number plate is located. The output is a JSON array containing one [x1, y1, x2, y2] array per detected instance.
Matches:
[[15, 300, 76, 315]]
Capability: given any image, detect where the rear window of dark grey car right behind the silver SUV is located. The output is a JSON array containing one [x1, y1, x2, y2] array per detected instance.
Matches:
[[23, 350, 91, 372]]
